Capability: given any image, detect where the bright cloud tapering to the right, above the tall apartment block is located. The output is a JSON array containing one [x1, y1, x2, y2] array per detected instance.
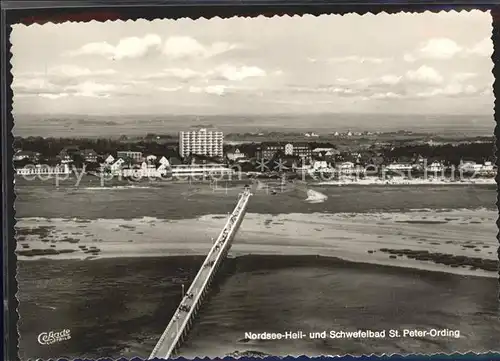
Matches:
[[162, 36, 237, 59]]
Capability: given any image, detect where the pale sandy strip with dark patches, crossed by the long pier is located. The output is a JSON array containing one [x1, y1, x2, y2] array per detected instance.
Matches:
[[17, 205, 498, 277]]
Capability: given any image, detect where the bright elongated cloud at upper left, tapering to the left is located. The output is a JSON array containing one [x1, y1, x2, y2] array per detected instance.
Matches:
[[69, 34, 161, 60]]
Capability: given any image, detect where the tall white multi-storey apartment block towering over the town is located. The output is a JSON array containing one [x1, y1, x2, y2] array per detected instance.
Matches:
[[179, 129, 224, 158]]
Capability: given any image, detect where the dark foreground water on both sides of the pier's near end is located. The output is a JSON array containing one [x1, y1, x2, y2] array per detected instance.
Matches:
[[19, 256, 500, 359]]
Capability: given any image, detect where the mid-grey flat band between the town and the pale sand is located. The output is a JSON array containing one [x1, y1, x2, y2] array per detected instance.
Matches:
[[16, 177, 496, 219]]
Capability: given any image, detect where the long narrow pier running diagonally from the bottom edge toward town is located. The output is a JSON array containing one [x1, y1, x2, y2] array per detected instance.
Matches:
[[149, 188, 252, 359]]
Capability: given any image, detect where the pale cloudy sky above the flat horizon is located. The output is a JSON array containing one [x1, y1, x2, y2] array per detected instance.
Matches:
[[11, 11, 494, 115]]
